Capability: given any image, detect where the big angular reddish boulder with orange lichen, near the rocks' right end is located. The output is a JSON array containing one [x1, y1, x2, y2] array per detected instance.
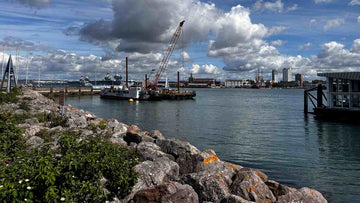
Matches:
[[230, 168, 276, 202]]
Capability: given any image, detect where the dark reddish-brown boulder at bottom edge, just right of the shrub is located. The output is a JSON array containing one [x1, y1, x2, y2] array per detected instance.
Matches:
[[133, 182, 199, 203]]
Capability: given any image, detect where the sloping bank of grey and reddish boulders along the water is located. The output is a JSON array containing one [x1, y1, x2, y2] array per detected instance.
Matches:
[[0, 89, 327, 203]]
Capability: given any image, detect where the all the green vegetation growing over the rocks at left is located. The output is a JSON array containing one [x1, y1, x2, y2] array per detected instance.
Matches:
[[0, 88, 139, 202]]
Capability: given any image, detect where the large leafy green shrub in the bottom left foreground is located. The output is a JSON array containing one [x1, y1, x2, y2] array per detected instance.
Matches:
[[0, 132, 138, 202]]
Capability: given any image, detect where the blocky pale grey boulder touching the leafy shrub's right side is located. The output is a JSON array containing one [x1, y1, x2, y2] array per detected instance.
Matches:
[[133, 157, 179, 191]]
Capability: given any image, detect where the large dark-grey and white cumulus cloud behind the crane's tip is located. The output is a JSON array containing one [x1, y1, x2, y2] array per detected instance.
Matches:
[[69, 0, 286, 53]]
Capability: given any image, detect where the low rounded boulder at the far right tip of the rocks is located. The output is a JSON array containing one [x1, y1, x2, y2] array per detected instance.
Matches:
[[278, 187, 327, 203]]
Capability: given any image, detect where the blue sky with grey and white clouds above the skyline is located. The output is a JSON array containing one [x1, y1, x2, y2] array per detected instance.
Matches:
[[0, 0, 360, 81]]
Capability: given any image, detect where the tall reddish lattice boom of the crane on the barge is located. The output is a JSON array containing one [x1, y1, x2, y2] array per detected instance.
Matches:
[[153, 20, 185, 89]]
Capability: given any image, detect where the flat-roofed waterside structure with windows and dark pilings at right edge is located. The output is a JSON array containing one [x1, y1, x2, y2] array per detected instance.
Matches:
[[304, 72, 360, 123]]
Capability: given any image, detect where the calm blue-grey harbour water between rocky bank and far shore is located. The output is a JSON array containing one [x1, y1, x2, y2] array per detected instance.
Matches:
[[67, 89, 360, 202]]
